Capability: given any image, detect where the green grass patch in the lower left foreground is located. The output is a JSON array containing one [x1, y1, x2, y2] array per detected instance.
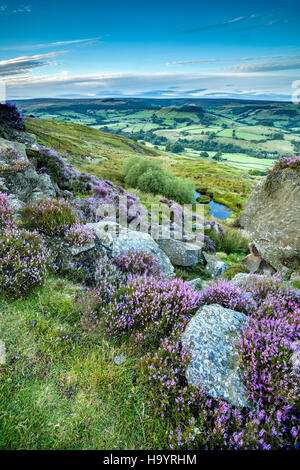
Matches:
[[0, 278, 168, 450]]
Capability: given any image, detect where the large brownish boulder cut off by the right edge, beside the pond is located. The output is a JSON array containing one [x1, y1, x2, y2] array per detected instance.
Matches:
[[236, 160, 300, 271]]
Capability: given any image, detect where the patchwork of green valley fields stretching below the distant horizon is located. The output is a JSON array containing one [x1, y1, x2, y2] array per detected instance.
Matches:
[[17, 99, 300, 169]]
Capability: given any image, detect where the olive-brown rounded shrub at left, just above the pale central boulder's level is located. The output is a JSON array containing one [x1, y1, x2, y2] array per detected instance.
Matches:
[[22, 198, 78, 236]]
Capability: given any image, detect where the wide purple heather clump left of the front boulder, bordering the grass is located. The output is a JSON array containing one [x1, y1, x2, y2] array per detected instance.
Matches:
[[95, 276, 199, 346]]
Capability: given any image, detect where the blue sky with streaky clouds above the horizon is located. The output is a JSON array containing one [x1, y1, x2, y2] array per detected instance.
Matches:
[[0, 0, 300, 101]]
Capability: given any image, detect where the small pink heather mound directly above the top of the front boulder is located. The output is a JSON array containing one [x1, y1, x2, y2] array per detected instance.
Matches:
[[198, 280, 255, 313]]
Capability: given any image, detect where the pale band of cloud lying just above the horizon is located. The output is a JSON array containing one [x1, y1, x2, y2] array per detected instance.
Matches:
[[7, 72, 297, 100]]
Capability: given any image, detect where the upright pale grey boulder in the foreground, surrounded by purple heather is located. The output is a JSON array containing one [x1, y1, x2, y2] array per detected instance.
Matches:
[[182, 304, 249, 408]]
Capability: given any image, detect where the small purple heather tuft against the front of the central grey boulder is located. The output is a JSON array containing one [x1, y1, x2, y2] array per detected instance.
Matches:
[[113, 250, 159, 275]]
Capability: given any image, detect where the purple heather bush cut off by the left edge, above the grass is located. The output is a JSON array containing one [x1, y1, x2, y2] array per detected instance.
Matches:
[[0, 228, 50, 295]]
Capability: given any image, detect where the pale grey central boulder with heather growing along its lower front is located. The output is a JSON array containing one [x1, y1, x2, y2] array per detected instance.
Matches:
[[87, 221, 174, 276]]
